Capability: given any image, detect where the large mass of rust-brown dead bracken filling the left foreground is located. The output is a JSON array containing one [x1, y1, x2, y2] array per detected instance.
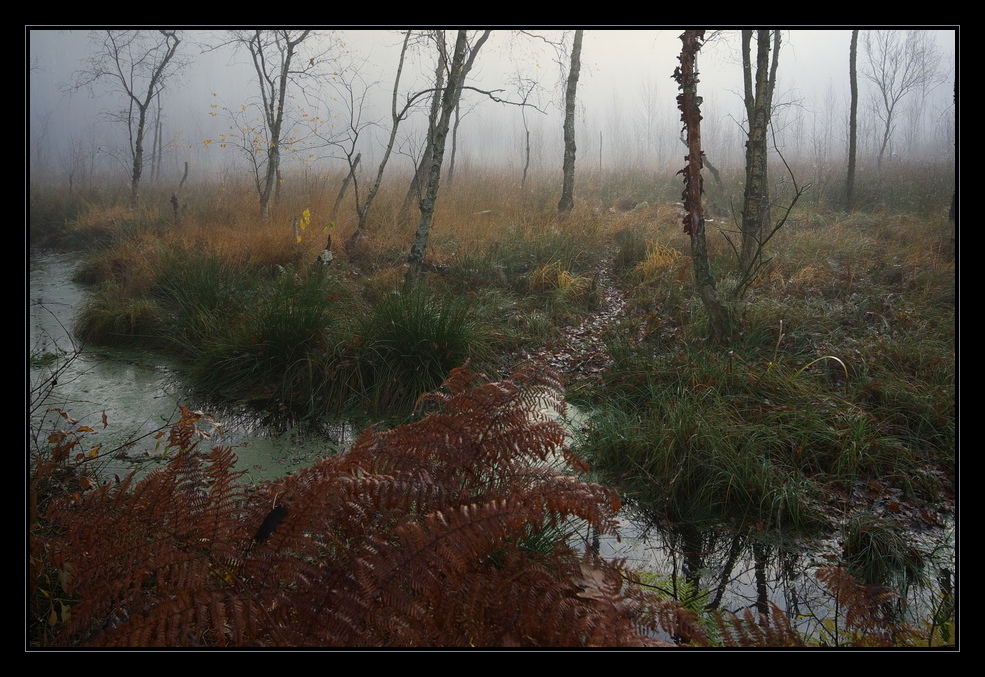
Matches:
[[31, 366, 673, 647]]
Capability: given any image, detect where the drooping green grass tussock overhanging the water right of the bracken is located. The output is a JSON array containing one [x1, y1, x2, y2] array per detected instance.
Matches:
[[582, 362, 821, 530]]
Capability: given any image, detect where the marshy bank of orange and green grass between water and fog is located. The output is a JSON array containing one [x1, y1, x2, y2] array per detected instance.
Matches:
[[31, 168, 957, 641]]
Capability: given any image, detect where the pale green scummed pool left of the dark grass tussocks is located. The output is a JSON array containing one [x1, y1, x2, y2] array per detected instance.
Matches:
[[27, 253, 353, 481]]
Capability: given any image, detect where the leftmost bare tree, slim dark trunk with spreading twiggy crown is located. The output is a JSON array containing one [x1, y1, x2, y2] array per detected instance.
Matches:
[[74, 30, 184, 205]]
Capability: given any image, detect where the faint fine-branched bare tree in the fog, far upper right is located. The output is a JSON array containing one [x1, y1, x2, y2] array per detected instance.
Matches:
[[862, 30, 947, 169]]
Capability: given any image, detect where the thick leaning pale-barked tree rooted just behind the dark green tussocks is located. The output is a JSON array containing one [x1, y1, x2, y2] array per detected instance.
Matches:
[[405, 30, 492, 288]]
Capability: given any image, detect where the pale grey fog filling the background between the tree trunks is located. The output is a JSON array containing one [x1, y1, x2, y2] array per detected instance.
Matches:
[[26, 28, 957, 184]]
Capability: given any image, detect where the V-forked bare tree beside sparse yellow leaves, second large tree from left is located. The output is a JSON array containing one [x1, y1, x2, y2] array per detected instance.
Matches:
[[233, 30, 338, 219]]
